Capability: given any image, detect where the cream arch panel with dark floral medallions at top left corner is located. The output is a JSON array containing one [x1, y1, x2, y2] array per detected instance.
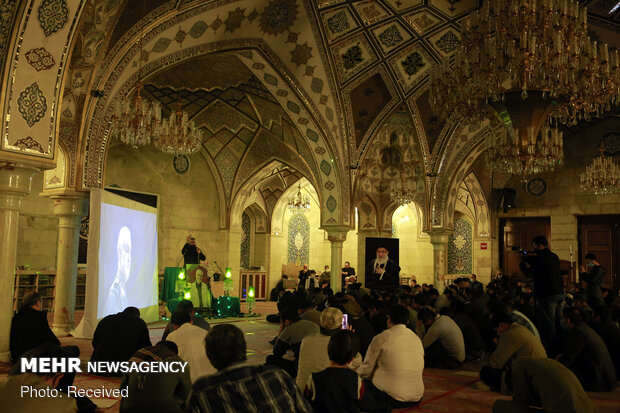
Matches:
[[0, 0, 86, 165]]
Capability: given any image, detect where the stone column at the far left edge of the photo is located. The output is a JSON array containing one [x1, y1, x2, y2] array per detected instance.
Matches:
[[0, 163, 36, 362]]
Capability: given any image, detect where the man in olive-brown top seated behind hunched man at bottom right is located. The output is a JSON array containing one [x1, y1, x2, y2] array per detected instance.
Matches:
[[480, 313, 547, 393]]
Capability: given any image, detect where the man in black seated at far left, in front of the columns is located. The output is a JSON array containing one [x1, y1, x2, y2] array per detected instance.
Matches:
[[9, 292, 60, 363]]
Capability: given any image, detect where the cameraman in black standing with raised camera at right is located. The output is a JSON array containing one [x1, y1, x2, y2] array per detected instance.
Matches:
[[519, 235, 564, 345]]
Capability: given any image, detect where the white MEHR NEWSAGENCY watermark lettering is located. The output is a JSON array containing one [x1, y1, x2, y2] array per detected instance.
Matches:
[[21, 357, 187, 374]]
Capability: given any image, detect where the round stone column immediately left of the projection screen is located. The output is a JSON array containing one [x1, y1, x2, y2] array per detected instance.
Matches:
[[51, 194, 88, 337]]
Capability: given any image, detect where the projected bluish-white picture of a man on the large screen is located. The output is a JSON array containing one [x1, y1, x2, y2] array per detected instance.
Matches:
[[97, 203, 157, 318]]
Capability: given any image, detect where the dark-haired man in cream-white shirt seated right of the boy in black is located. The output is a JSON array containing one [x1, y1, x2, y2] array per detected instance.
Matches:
[[357, 305, 424, 407]]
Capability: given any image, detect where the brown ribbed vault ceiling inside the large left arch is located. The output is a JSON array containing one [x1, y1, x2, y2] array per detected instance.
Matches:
[[144, 54, 318, 206]]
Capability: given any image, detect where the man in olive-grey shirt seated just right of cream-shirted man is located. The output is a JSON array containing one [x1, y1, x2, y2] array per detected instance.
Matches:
[[418, 307, 465, 369]]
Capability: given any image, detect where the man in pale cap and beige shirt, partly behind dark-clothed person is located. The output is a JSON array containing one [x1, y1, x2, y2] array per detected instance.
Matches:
[[295, 307, 362, 390]]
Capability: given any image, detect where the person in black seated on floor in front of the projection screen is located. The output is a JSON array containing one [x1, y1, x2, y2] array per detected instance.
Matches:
[[90, 307, 151, 370]]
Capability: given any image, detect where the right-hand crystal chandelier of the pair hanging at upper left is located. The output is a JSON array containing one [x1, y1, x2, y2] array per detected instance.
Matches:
[[154, 104, 202, 155]]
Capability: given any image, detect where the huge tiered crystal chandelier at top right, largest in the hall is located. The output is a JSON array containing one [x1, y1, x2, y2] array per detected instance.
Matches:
[[431, 0, 620, 175]]
